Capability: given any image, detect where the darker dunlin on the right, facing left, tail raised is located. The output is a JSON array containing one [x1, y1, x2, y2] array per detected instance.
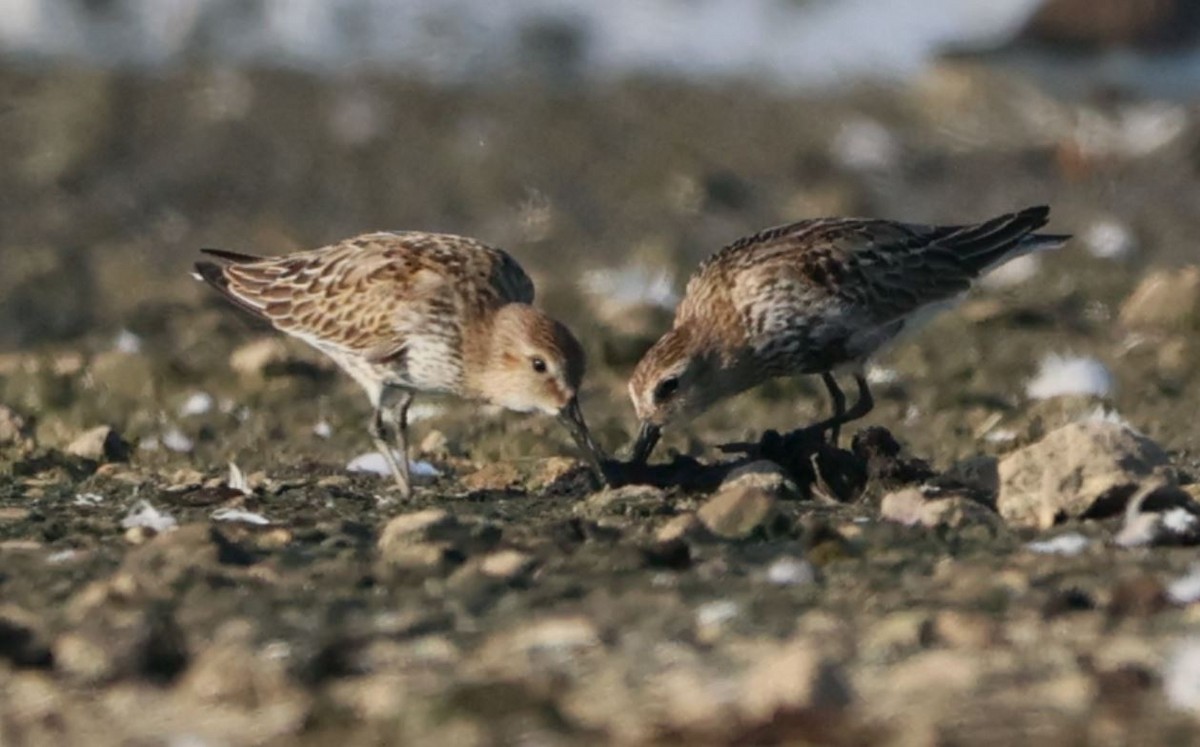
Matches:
[[629, 207, 1069, 462]]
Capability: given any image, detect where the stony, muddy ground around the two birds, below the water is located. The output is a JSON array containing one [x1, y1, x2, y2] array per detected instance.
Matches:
[[0, 67, 1200, 746]]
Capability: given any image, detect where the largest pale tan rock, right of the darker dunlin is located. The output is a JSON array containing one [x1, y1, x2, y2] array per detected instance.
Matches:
[[996, 420, 1170, 528]]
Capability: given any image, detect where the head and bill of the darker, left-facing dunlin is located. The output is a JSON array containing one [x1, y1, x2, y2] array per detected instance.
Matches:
[[629, 325, 724, 462]]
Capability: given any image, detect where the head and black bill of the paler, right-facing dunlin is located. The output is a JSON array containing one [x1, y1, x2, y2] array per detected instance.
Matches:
[[473, 304, 604, 477]]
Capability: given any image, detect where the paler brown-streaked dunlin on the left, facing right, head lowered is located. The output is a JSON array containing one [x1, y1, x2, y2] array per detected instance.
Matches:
[[196, 232, 602, 496]]
